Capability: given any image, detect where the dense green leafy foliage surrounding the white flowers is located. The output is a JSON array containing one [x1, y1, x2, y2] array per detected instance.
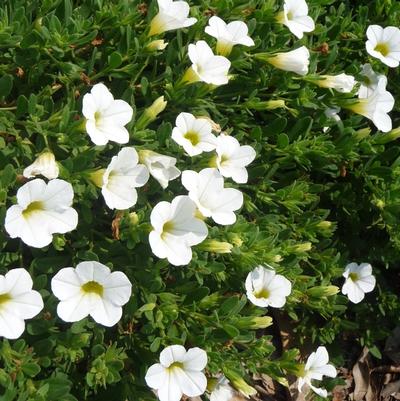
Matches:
[[0, 0, 400, 401]]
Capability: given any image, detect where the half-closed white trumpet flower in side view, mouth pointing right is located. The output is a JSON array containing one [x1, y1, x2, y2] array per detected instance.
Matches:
[[266, 46, 310, 75]]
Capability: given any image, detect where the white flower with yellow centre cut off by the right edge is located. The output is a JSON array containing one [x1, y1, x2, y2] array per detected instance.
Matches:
[[365, 25, 400, 67]]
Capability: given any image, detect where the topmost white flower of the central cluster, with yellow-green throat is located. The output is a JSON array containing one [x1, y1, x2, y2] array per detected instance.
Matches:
[[172, 113, 216, 156]]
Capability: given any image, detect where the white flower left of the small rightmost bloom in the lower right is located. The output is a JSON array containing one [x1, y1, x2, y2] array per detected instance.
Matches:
[[245, 266, 292, 308]]
